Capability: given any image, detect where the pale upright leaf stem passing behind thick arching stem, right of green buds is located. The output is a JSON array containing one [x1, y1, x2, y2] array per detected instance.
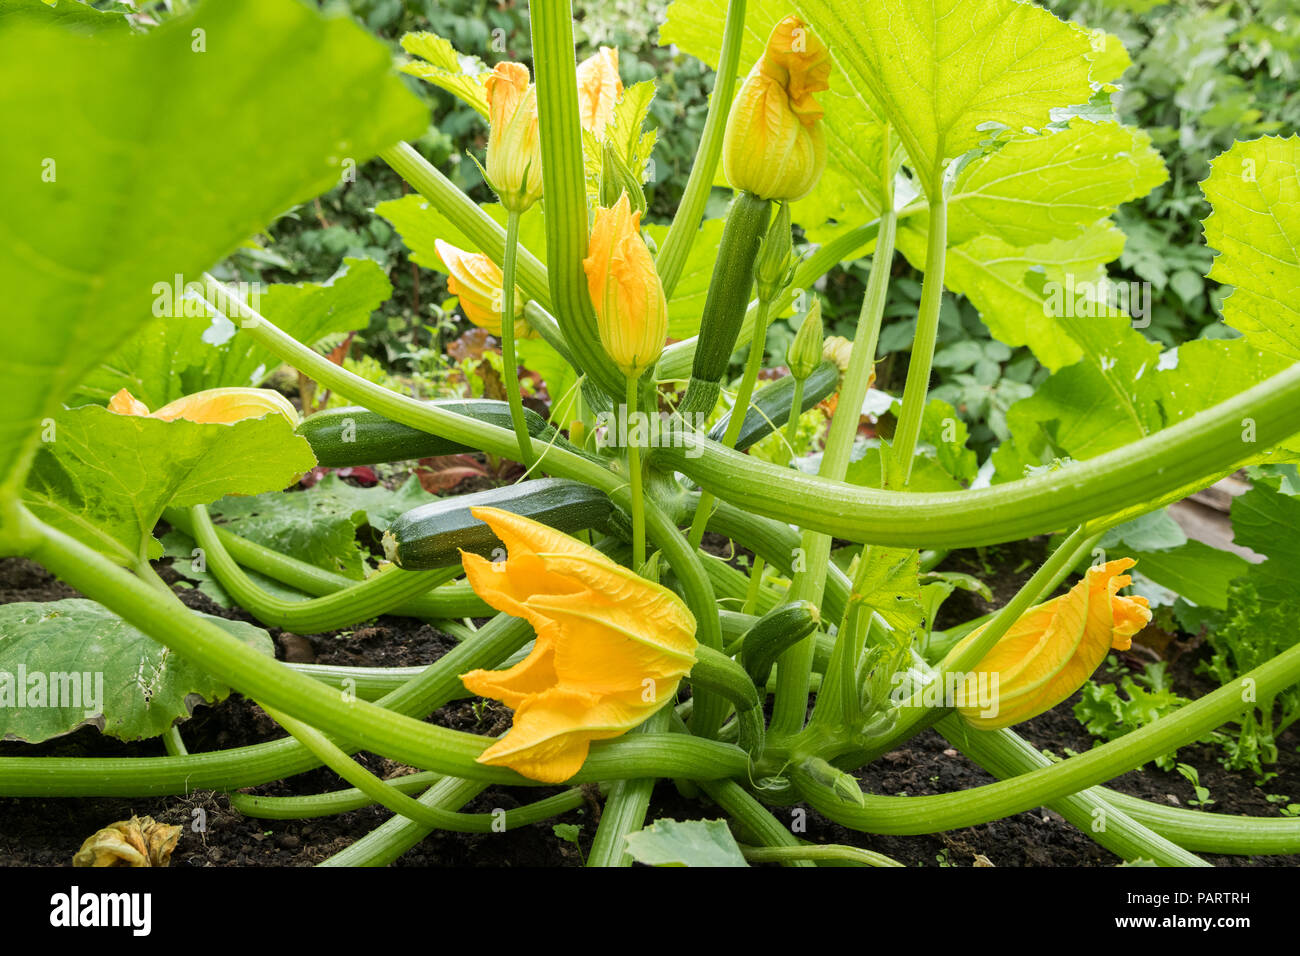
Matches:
[[764, 208, 897, 736]]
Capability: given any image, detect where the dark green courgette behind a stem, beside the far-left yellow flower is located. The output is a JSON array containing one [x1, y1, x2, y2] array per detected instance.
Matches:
[[298, 398, 572, 468]]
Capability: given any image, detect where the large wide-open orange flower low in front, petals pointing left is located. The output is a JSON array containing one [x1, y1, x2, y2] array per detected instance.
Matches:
[[460, 507, 696, 783]]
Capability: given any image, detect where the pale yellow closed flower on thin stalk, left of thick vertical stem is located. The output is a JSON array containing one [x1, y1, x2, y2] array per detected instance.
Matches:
[[484, 62, 542, 212]]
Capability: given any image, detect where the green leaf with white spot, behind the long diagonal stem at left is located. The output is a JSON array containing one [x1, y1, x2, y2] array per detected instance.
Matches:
[[77, 258, 393, 408]]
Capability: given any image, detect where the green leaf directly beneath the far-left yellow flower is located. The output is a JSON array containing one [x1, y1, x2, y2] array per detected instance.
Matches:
[[23, 405, 316, 566]]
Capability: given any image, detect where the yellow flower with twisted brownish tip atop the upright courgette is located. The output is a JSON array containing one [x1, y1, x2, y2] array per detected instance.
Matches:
[[723, 17, 831, 200]]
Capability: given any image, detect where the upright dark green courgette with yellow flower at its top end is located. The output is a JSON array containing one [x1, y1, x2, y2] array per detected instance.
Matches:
[[679, 193, 772, 415]]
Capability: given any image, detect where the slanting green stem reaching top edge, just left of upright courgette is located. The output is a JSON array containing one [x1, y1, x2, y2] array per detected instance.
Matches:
[[654, 0, 745, 299]]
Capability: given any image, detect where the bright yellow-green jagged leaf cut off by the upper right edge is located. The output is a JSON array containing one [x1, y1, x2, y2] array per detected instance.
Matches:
[[1201, 135, 1300, 362]]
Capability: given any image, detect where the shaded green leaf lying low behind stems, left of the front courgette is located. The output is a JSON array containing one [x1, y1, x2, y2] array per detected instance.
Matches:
[[211, 473, 434, 580]]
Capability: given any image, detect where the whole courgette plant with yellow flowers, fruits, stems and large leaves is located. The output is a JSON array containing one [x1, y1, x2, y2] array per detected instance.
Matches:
[[0, 0, 1300, 865]]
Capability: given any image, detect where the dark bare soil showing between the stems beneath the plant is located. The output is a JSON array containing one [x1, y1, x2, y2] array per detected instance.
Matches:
[[0, 540, 1300, 866]]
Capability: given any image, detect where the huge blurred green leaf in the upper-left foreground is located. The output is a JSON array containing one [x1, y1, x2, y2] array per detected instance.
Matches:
[[0, 0, 428, 535]]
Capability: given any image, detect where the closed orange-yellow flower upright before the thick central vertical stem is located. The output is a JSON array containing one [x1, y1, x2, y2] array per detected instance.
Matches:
[[582, 193, 668, 377]]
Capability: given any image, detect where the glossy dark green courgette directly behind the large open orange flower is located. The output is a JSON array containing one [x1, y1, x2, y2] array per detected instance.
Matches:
[[384, 479, 614, 571]]
